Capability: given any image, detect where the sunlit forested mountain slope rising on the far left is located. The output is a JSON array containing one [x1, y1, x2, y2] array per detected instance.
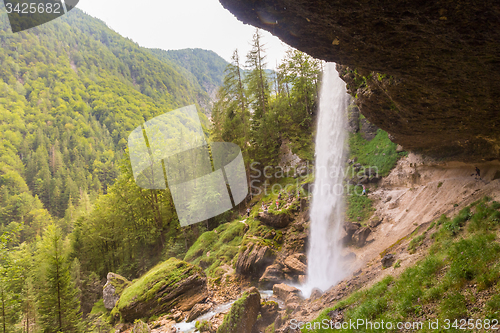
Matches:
[[0, 9, 206, 231]]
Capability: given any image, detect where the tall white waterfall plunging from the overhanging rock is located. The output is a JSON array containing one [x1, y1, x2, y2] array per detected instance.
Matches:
[[301, 63, 348, 297]]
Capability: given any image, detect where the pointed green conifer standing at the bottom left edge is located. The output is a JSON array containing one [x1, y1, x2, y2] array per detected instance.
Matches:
[[38, 225, 81, 333]]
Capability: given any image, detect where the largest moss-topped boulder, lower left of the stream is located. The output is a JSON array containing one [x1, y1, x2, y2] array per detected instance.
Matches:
[[113, 258, 208, 322]]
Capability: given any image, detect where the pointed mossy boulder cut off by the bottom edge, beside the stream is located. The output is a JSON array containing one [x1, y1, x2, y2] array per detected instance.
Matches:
[[217, 288, 260, 333]]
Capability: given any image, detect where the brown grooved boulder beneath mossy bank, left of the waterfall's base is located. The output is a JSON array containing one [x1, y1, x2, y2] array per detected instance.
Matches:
[[236, 243, 274, 277]]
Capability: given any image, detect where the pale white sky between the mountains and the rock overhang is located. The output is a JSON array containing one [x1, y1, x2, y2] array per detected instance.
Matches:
[[77, 0, 288, 68]]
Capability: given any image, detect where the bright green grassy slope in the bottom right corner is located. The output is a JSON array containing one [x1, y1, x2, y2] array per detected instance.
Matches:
[[303, 198, 500, 332]]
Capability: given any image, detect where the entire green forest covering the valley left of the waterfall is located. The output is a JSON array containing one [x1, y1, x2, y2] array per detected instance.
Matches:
[[0, 9, 322, 333]]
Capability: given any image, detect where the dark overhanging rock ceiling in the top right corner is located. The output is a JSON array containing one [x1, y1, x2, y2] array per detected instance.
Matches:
[[219, 0, 500, 160]]
